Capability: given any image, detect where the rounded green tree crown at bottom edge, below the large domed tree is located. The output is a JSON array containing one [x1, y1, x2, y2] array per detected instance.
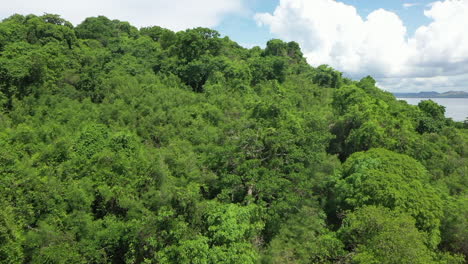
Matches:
[[339, 206, 446, 264]]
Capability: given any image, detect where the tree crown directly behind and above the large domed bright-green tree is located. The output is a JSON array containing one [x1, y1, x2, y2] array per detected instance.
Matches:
[[329, 80, 419, 161]]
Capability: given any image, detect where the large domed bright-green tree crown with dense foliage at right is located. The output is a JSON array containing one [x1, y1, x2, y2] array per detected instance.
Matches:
[[336, 149, 442, 247]]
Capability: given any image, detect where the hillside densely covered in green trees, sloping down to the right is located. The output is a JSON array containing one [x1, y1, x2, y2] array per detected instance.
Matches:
[[0, 14, 468, 264]]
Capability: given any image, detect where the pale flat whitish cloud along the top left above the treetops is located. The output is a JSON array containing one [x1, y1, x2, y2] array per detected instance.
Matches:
[[0, 0, 244, 31]]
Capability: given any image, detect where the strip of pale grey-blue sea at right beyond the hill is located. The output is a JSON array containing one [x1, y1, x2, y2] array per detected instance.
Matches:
[[397, 98, 468, 121]]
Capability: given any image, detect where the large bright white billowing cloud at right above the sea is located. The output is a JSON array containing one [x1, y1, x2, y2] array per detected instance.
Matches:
[[255, 0, 468, 90]]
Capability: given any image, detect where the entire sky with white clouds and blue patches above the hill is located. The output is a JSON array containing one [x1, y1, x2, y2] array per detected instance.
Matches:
[[0, 0, 468, 92]]
